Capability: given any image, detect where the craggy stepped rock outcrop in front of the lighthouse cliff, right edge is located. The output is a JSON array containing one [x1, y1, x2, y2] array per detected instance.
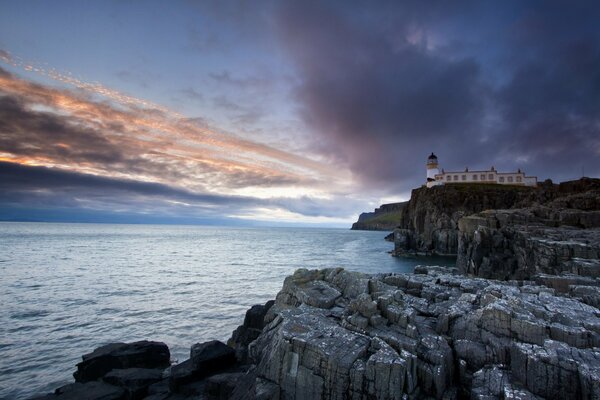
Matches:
[[456, 208, 600, 280]]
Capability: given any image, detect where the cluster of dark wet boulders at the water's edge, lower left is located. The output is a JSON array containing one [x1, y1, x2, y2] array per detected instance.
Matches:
[[29, 301, 274, 400]]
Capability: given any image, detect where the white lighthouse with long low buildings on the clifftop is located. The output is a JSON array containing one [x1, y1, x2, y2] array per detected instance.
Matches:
[[427, 153, 537, 187]]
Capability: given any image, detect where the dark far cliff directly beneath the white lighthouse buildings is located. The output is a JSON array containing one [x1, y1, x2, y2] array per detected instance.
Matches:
[[394, 178, 600, 255]]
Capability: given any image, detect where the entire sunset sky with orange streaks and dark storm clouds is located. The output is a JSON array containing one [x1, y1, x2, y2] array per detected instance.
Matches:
[[0, 0, 600, 227]]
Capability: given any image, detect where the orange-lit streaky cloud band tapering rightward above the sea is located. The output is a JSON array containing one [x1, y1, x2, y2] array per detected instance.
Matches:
[[0, 65, 342, 193]]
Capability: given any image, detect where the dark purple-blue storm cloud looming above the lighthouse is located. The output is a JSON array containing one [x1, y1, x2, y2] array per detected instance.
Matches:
[[277, 2, 600, 190]]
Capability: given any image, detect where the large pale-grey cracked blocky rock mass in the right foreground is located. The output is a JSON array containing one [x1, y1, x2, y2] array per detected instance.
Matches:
[[241, 266, 600, 399]]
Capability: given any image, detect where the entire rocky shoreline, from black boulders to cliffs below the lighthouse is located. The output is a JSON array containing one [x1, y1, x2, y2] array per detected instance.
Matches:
[[31, 179, 600, 400]]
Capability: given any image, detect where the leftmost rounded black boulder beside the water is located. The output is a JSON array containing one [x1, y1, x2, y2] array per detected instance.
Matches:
[[73, 340, 170, 382]]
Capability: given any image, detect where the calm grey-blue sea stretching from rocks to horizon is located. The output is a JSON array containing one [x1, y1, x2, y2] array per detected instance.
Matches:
[[0, 223, 448, 399]]
